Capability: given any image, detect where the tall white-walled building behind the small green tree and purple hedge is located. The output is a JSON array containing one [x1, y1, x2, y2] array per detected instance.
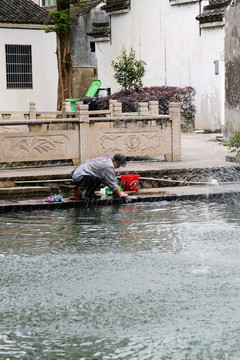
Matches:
[[96, 0, 226, 130]]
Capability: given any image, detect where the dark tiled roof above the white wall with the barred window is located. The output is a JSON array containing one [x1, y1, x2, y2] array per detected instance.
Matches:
[[0, 0, 49, 24]]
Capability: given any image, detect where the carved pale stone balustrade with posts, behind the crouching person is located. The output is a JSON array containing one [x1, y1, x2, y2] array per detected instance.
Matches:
[[0, 100, 181, 164]]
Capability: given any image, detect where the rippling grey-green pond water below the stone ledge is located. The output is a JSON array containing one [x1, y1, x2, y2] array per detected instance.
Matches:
[[0, 199, 240, 360]]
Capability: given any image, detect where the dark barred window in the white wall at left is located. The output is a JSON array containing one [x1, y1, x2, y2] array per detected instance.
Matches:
[[5, 45, 32, 89]]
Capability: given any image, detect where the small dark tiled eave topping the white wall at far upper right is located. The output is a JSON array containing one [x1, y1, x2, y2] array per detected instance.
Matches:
[[196, 0, 231, 24]]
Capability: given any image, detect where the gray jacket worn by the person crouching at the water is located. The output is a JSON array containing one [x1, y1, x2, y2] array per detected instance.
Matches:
[[72, 155, 118, 192]]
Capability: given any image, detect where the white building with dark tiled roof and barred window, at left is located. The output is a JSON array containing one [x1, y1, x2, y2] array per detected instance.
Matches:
[[0, 0, 58, 111]]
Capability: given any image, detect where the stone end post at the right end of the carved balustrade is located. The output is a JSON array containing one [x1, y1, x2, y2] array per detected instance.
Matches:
[[169, 103, 181, 161]]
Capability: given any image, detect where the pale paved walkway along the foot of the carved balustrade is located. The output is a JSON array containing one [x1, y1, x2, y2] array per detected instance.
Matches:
[[0, 133, 239, 181]]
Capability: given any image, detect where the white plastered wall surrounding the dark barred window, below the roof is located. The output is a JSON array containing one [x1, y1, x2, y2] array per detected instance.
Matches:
[[0, 28, 58, 111]]
